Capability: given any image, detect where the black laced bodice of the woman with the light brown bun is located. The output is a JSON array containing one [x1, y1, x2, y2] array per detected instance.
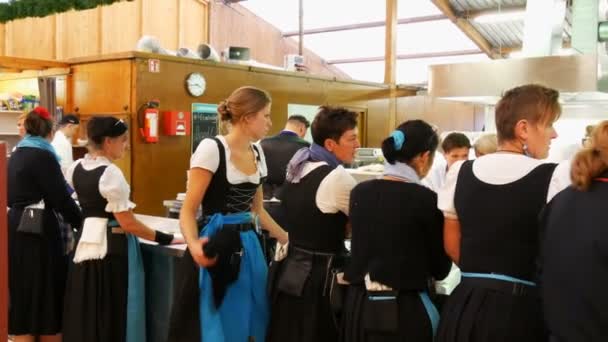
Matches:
[[203, 138, 263, 216]]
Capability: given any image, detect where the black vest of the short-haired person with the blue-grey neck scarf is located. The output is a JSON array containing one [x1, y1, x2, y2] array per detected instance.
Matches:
[[281, 165, 348, 253]]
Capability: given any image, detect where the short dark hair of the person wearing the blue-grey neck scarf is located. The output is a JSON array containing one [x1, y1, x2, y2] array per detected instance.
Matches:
[[310, 106, 357, 146]]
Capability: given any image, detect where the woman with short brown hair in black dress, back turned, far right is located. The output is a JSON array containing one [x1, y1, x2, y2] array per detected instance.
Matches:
[[437, 85, 561, 342]]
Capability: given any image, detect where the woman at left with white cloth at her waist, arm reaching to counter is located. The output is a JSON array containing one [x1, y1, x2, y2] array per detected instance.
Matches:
[[63, 117, 173, 342]]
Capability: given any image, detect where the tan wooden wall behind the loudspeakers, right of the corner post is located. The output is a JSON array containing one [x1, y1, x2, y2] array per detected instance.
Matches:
[[209, 2, 350, 79]]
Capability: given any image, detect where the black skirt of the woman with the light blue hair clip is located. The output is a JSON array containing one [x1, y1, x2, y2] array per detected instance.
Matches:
[[340, 285, 433, 342]]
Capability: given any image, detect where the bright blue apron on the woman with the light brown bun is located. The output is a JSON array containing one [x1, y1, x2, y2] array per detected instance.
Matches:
[[199, 212, 270, 342]]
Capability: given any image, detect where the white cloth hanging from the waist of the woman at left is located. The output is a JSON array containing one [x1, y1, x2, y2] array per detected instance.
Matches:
[[74, 217, 108, 264]]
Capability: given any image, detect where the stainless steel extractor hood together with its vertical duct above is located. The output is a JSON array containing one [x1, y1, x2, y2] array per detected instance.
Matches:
[[428, 0, 608, 105]]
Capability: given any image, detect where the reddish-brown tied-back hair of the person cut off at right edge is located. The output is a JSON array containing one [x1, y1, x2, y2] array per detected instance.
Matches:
[[570, 120, 608, 191]]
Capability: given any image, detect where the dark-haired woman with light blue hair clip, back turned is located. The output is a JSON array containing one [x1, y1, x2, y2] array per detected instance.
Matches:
[[342, 120, 452, 342]]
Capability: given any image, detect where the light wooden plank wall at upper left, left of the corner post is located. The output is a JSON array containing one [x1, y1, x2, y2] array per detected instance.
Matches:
[[0, 0, 209, 60]]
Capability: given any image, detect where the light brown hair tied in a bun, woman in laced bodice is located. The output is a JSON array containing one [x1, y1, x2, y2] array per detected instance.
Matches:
[[217, 86, 272, 124]]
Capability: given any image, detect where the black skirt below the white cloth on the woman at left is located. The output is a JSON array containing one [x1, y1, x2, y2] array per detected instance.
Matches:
[[63, 234, 129, 342]]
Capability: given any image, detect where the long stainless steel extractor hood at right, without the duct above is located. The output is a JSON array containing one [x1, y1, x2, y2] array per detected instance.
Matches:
[[428, 53, 608, 104]]
